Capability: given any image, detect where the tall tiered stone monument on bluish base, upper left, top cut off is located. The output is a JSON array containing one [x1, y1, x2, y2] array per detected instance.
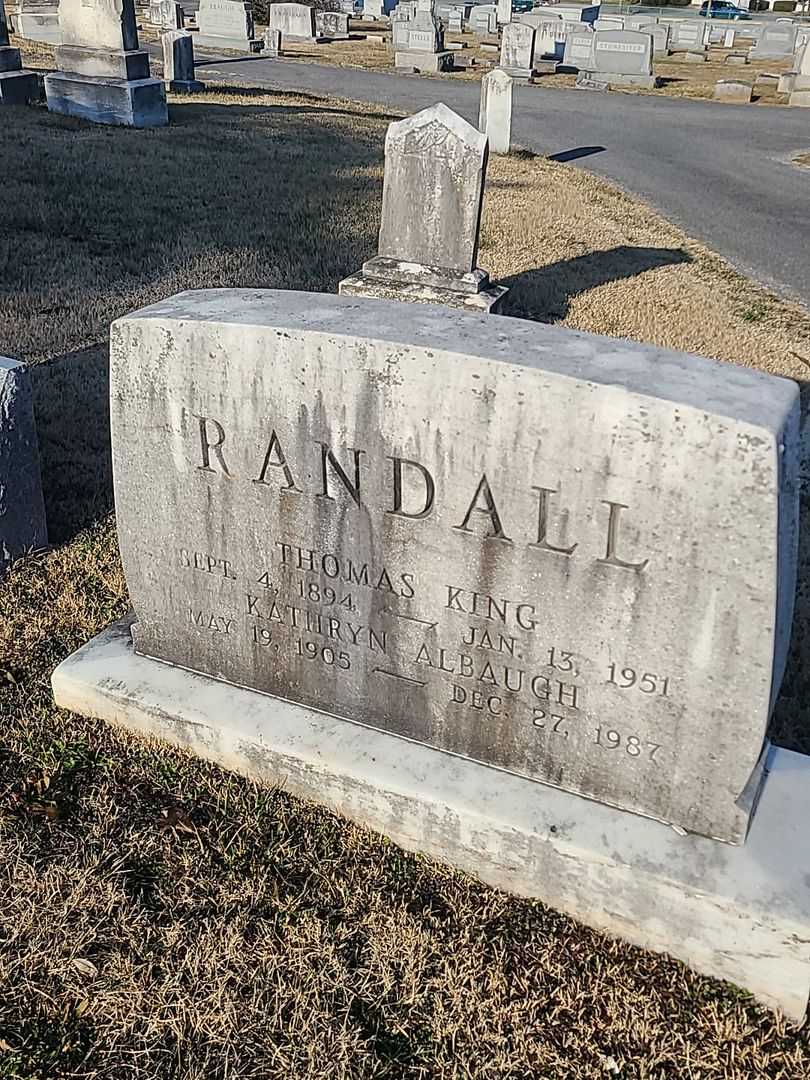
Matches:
[[44, 0, 168, 127]]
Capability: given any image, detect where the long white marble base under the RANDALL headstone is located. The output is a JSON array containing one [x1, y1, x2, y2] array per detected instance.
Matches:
[[53, 621, 810, 1023]]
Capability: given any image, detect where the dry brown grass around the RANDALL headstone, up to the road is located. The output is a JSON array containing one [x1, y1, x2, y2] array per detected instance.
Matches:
[[0, 78, 810, 1080]]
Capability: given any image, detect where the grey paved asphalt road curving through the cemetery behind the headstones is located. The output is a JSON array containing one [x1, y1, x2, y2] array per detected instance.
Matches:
[[198, 57, 810, 307]]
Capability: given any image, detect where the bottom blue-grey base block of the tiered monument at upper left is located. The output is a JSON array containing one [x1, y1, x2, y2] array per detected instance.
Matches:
[[45, 71, 168, 127]]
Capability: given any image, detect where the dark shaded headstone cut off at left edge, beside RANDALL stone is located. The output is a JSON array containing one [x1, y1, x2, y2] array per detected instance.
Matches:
[[0, 356, 48, 577]]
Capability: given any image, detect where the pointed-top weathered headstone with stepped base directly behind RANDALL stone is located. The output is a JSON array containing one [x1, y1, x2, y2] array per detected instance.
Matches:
[[340, 103, 505, 311]]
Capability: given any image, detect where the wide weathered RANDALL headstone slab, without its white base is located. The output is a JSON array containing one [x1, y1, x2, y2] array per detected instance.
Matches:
[[111, 287, 798, 842]]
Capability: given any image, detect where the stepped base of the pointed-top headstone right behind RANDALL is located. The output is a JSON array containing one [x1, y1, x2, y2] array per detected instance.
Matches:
[[338, 255, 508, 314]]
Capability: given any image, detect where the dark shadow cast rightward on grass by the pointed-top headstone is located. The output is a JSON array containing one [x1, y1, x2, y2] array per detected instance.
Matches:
[[499, 244, 691, 323]]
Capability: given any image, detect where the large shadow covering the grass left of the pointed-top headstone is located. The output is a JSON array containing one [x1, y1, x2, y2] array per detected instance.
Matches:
[[0, 95, 387, 543]]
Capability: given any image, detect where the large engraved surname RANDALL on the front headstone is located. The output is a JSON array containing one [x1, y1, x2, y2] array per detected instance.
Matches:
[[191, 414, 649, 573]]
